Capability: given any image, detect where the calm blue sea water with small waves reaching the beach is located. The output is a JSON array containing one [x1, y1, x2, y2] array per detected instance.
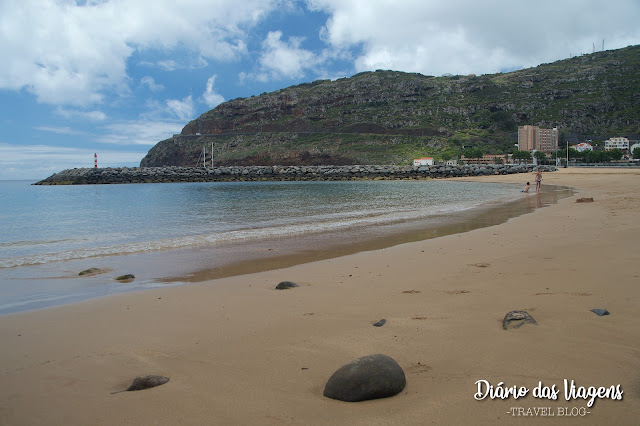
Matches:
[[0, 180, 552, 314]]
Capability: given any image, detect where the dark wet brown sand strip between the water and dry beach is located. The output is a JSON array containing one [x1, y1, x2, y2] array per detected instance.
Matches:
[[158, 185, 574, 283]]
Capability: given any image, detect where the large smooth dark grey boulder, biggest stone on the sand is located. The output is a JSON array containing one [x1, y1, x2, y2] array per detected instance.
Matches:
[[324, 354, 407, 402]]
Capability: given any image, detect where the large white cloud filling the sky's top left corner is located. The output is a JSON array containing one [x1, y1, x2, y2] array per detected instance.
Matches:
[[0, 0, 281, 106]]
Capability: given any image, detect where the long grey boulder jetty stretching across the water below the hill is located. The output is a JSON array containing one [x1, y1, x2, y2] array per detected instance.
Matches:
[[34, 164, 556, 185]]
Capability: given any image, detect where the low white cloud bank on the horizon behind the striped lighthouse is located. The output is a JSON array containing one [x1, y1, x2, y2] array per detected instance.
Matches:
[[0, 143, 147, 180]]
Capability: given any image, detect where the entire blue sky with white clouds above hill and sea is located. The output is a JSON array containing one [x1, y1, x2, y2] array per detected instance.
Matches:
[[0, 0, 640, 179]]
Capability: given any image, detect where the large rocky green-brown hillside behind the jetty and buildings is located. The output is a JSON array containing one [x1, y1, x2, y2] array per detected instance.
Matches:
[[141, 46, 640, 166]]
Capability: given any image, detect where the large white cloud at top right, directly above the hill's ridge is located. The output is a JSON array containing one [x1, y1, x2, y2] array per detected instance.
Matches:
[[307, 0, 640, 75]]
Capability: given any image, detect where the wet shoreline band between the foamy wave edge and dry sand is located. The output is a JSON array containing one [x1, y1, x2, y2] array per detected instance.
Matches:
[[0, 180, 572, 315]]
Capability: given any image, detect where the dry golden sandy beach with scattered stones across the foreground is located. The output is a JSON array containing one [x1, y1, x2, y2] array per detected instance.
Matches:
[[0, 168, 640, 425]]
